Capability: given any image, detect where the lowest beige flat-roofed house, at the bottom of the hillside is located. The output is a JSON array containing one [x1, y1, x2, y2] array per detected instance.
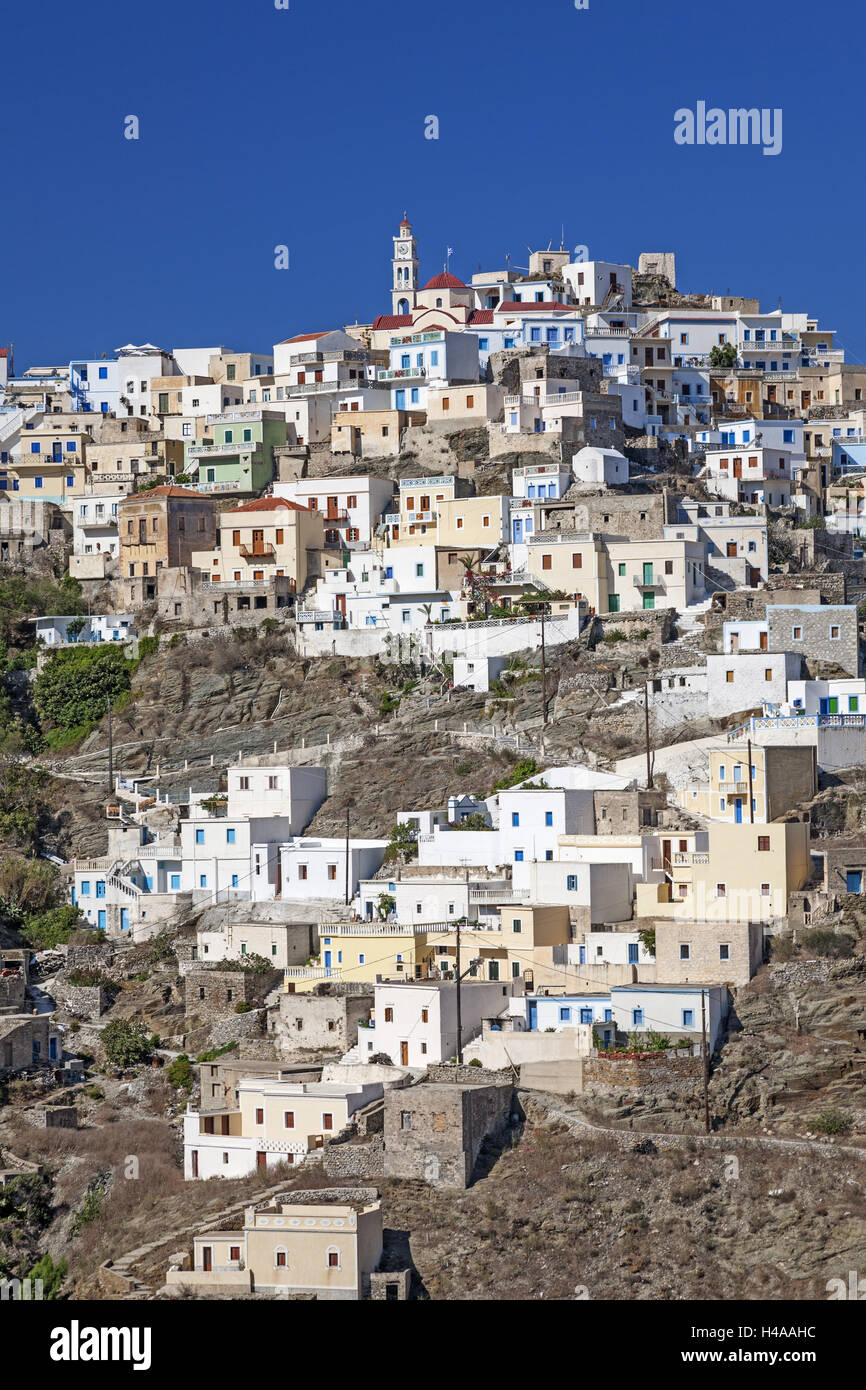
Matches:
[[165, 1188, 383, 1301]]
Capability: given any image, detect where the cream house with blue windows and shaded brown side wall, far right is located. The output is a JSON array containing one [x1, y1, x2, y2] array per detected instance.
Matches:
[[678, 744, 817, 824]]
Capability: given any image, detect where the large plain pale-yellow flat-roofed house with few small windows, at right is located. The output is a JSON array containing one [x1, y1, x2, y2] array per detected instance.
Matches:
[[635, 820, 812, 922]]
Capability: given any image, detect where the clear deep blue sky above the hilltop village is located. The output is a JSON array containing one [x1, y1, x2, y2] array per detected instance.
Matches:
[[0, 0, 866, 370]]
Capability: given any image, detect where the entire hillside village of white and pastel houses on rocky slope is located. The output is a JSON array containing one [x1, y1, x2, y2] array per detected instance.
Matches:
[[0, 227, 866, 1301]]
